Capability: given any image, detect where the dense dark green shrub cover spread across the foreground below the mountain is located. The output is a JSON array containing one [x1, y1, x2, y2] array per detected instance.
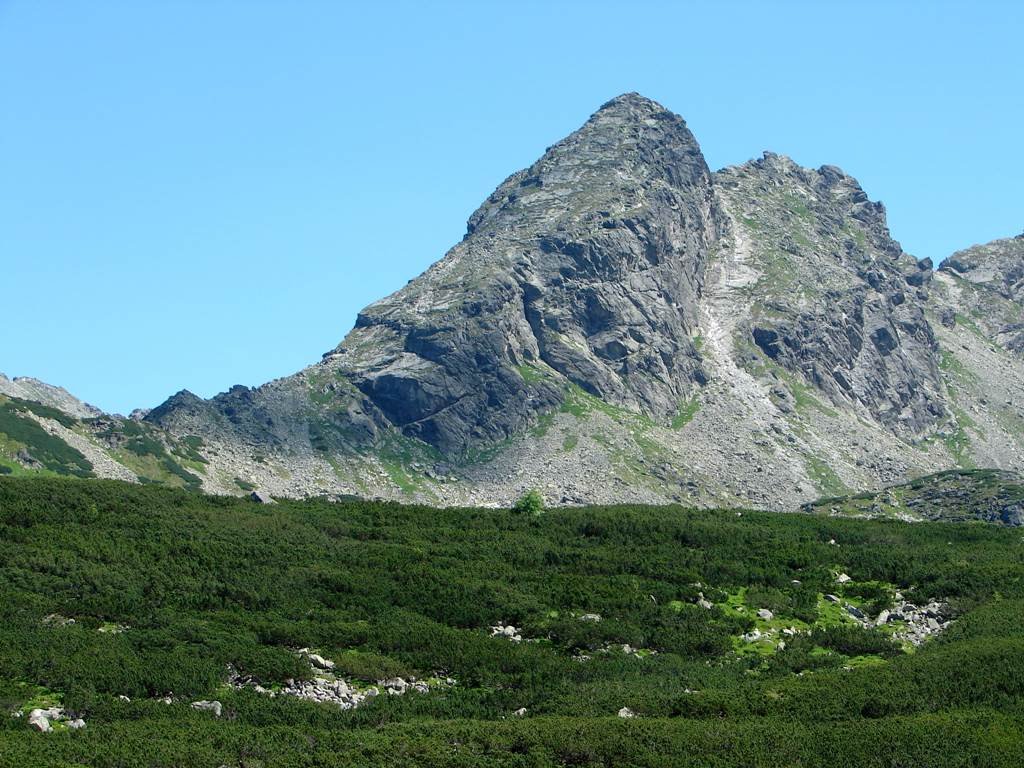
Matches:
[[0, 476, 1024, 768]]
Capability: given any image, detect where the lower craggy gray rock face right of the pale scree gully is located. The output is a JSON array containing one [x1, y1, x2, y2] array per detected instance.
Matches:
[[715, 154, 946, 435]]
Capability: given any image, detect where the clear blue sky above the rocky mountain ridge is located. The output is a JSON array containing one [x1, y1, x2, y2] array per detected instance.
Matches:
[[0, 0, 1024, 413]]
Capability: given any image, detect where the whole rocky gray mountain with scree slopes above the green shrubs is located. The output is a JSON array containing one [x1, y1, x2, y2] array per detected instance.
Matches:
[[6, 94, 1024, 509]]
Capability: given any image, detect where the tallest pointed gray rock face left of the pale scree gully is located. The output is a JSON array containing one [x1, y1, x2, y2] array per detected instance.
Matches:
[[328, 94, 721, 456]]
